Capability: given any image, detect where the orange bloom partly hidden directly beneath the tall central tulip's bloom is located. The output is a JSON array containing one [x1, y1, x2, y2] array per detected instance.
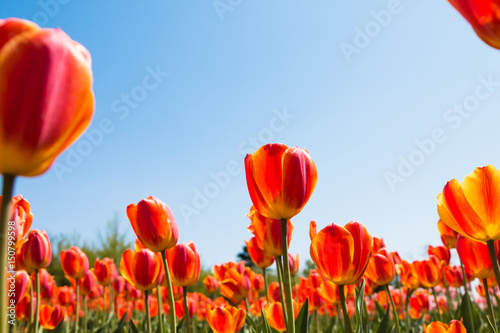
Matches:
[[247, 206, 293, 257]]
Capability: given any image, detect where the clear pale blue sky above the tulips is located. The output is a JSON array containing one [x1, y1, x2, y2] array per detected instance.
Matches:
[[0, 0, 500, 267]]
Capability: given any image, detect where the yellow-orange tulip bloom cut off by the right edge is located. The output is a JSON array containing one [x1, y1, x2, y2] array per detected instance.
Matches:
[[438, 165, 500, 243]]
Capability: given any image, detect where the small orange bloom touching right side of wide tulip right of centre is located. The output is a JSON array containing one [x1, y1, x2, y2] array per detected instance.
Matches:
[[365, 247, 396, 286]]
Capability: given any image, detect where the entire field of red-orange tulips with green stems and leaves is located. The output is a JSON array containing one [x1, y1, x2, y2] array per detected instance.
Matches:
[[0, 0, 500, 333]]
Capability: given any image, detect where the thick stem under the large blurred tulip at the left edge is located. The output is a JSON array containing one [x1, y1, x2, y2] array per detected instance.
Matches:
[[0, 175, 16, 332]]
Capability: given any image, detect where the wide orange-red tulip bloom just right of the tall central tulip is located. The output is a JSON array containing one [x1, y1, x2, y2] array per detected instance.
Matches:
[[310, 221, 372, 285]]
